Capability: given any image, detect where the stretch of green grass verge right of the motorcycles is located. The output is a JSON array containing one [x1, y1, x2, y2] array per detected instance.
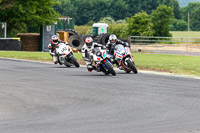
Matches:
[[134, 54, 200, 76]]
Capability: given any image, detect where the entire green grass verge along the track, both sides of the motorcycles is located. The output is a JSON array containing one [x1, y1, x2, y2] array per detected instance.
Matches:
[[0, 51, 200, 76]]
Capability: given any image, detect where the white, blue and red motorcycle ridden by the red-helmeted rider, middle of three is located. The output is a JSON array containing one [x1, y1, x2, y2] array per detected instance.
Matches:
[[92, 47, 116, 76]]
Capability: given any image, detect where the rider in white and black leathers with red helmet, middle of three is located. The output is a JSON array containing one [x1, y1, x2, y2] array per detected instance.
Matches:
[[81, 37, 106, 72]]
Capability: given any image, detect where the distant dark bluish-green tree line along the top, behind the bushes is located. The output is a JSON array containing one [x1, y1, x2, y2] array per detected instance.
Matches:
[[54, 0, 181, 25]]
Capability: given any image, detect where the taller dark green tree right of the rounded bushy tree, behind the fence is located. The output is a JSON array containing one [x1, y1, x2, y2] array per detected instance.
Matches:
[[151, 5, 174, 37]]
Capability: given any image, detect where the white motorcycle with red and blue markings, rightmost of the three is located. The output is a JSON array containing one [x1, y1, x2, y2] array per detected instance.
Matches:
[[114, 44, 138, 74]]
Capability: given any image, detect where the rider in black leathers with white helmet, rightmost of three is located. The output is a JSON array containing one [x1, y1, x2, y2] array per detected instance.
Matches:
[[106, 34, 129, 67]]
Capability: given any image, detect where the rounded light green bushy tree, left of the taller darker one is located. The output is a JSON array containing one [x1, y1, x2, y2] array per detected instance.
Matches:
[[127, 11, 154, 36]]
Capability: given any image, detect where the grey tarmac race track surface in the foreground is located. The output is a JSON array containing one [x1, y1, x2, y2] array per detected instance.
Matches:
[[0, 59, 200, 133]]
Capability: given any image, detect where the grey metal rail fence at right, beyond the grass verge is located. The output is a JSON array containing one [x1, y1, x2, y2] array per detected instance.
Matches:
[[129, 36, 200, 53]]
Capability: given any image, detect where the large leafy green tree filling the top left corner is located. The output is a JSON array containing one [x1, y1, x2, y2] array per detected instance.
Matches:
[[0, 0, 59, 36]]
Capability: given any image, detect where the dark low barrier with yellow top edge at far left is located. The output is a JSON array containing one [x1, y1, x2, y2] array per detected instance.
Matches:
[[0, 38, 21, 51]]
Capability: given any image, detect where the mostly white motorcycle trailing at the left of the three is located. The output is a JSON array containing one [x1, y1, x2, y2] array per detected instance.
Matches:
[[56, 42, 80, 67]]
